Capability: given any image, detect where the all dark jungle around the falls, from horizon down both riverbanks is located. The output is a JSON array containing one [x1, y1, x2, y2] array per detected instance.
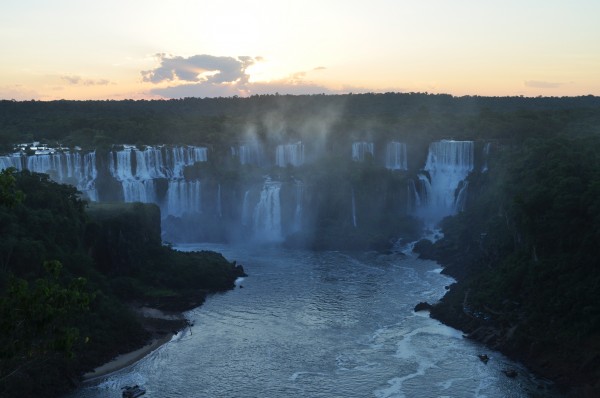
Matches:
[[0, 93, 600, 396]]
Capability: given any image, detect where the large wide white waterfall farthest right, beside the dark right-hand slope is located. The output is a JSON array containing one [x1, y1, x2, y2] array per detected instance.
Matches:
[[418, 140, 473, 223]]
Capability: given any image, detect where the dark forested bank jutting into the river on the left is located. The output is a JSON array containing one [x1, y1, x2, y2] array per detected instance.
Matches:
[[0, 170, 243, 397]]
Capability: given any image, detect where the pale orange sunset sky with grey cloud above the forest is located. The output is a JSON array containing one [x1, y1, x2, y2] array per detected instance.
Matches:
[[0, 0, 600, 100]]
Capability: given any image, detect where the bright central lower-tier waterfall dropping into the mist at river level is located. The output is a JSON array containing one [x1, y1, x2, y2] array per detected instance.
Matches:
[[253, 178, 283, 242]]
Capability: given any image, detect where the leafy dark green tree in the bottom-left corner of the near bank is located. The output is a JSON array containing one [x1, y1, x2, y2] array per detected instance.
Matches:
[[0, 261, 93, 392]]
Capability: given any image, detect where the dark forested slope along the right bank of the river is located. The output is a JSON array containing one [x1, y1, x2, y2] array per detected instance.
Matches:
[[427, 134, 600, 393]]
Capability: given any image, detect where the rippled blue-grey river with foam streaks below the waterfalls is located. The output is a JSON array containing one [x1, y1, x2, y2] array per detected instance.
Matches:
[[70, 244, 553, 398]]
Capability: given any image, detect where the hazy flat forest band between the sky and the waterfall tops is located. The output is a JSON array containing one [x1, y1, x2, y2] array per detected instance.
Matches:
[[0, 93, 600, 153]]
